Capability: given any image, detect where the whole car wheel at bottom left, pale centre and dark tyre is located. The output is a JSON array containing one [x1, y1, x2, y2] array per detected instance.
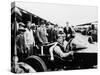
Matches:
[[12, 55, 47, 73]]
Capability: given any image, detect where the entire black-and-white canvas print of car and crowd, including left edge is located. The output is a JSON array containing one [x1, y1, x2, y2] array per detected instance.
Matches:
[[11, 1, 98, 74]]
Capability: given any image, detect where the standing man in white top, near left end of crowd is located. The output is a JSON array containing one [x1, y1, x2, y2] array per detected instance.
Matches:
[[24, 21, 35, 56]]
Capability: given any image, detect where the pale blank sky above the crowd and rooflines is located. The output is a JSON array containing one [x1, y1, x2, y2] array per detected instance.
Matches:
[[16, 2, 98, 26]]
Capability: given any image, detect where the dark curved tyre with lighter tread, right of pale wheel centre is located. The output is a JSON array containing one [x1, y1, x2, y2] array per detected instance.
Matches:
[[24, 55, 47, 72]]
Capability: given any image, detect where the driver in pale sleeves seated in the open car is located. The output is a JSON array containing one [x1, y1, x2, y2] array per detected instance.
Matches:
[[49, 31, 73, 60]]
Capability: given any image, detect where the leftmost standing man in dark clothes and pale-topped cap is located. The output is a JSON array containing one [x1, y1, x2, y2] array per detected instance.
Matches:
[[16, 26, 26, 61]]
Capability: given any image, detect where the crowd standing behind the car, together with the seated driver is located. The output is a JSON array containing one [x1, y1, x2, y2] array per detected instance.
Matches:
[[11, 21, 75, 60]]
